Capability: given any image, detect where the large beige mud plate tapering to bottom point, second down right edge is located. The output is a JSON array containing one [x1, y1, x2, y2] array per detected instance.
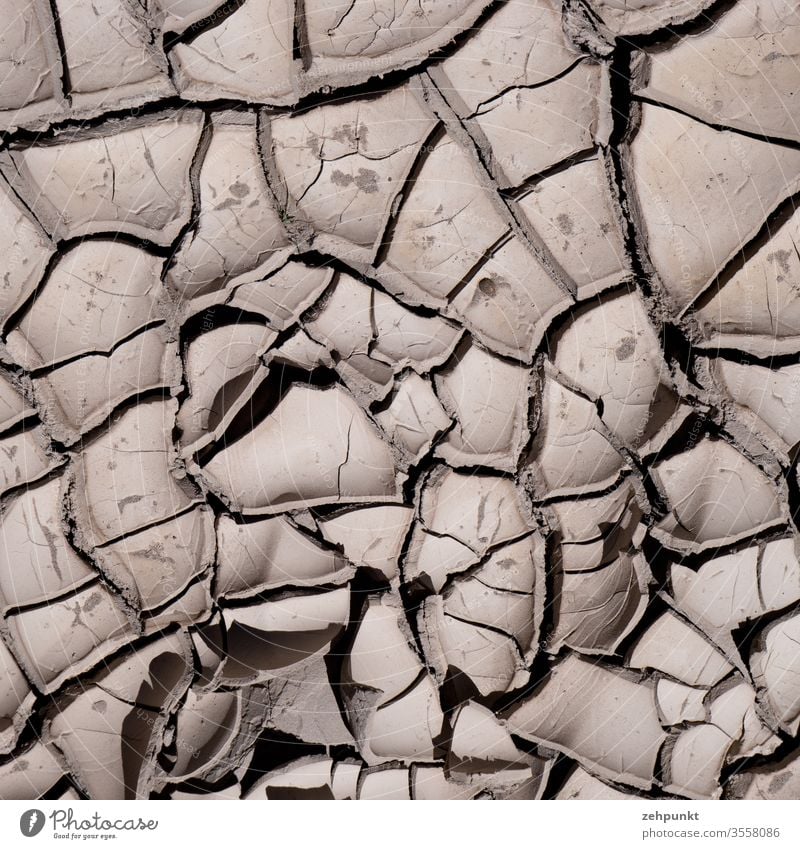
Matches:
[[628, 103, 800, 310]]
